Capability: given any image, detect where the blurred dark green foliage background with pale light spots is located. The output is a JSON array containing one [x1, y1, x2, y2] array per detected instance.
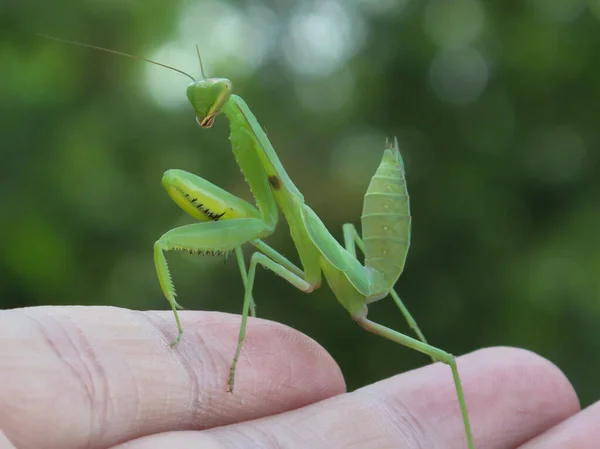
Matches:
[[0, 0, 600, 405]]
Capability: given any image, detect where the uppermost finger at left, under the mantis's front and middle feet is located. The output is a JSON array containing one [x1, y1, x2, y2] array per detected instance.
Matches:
[[0, 307, 345, 449]]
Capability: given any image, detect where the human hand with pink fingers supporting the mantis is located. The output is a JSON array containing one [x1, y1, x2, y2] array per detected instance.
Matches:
[[0, 307, 600, 449]]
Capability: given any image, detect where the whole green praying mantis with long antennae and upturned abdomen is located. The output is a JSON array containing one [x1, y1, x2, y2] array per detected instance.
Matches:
[[44, 36, 475, 449]]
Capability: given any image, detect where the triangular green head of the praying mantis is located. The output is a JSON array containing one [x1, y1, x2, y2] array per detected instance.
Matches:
[[186, 78, 232, 128]]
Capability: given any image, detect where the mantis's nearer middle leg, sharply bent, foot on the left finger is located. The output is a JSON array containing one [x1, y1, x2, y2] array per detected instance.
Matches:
[[228, 250, 314, 393]]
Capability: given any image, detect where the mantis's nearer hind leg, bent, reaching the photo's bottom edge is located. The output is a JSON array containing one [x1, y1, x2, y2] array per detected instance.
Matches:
[[355, 317, 475, 449]]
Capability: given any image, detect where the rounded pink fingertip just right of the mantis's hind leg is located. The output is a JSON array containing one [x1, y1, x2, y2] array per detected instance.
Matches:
[[459, 347, 580, 447]]
